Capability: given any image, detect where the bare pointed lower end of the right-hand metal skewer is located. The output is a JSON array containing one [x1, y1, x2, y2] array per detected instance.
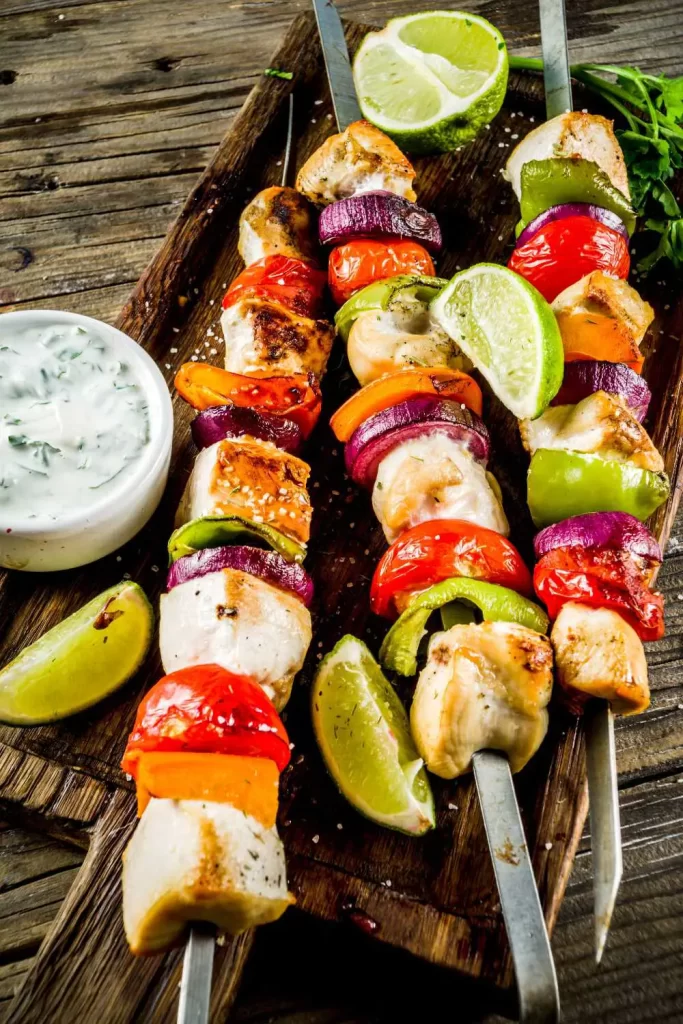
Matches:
[[585, 700, 624, 964]]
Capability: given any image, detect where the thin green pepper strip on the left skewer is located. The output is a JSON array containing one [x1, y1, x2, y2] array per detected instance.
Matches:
[[168, 515, 306, 562]]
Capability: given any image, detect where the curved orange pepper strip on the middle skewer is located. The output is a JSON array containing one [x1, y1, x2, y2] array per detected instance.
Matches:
[[330, 367, 482, 441]]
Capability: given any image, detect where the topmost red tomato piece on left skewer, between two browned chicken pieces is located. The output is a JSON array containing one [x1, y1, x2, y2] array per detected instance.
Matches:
[[222, 254, 327, 318]]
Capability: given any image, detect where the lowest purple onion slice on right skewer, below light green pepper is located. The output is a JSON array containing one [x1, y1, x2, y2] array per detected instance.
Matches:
[[533, 512, 661, 562]]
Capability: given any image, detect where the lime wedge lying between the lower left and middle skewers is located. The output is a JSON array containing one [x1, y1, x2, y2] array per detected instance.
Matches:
[[311, 636, 434, 836]]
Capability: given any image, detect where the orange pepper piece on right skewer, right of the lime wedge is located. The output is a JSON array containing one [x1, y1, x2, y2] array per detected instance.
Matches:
[[556, 310, 645, 374]]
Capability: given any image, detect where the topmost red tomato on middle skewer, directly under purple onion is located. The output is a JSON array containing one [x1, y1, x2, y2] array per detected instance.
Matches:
[[328, 238, 435, 306]]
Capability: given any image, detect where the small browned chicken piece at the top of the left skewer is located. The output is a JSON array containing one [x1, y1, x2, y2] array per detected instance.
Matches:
[[238, 185, 317, 266]]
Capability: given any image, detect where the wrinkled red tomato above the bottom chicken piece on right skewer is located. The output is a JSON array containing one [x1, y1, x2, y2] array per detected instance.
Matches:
[[533, 548, 664, 640]]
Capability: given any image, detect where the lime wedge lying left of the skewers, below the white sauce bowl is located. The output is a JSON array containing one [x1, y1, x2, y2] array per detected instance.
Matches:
[[0, 581, 155, 725]]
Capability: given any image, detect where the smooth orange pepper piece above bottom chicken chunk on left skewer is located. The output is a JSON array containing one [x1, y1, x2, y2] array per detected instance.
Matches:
[[136, 751, 280, 828]]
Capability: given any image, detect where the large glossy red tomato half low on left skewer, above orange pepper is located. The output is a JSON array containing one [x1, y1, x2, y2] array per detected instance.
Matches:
[[121, 665, 290, 777]]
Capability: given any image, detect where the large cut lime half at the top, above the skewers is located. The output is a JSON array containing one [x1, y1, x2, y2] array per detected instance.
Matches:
[[353, 10, 508, 153]]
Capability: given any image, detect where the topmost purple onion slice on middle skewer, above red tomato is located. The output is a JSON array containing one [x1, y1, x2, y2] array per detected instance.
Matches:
[[317, 191, 443, 253]]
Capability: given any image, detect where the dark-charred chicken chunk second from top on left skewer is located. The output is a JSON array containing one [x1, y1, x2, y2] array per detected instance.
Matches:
[[220, 298, 335, 377]]
